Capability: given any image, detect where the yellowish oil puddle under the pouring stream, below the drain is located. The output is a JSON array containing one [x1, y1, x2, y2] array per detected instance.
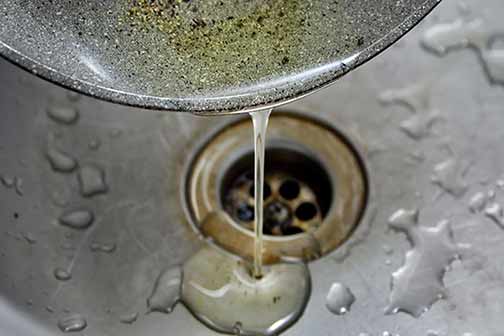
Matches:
[[181, 248, 311, 336]]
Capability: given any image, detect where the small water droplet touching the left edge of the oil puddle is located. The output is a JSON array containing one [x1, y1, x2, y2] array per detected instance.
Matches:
[[147, 267, 182, 314]]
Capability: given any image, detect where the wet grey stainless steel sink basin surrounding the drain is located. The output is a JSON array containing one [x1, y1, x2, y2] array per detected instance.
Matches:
[[0, 0, 504, 336]]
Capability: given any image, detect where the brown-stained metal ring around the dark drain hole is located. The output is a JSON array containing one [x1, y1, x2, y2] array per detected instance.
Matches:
[[184, 113, 367, 263]]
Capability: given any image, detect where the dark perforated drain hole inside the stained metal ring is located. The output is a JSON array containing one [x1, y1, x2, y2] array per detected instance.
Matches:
[[221, 147, 332, 236]]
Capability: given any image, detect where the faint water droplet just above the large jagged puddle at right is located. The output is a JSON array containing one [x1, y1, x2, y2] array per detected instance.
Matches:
[[432, 158, 469, 198]]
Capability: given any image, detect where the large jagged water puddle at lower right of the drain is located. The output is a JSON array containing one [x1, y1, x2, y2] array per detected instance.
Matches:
[[385, 209, 468, 317]]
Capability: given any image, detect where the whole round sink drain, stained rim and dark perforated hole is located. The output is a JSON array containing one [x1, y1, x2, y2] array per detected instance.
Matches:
[[184, 113, 367, 263]]
